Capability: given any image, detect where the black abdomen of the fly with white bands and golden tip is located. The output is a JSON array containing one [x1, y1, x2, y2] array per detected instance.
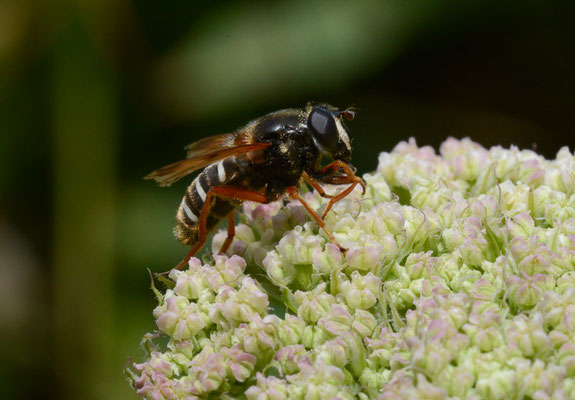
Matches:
[[174, 157, 241, 245]]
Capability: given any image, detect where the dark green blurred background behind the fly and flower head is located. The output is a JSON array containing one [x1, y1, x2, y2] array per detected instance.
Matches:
[[0, 0, 575, 399]]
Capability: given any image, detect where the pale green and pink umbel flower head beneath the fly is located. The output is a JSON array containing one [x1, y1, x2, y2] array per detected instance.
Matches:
[[128, 139, 575, 400]]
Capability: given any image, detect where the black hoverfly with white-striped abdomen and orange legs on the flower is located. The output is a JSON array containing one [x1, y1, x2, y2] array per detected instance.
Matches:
[[145, 104, 365, 269]]
